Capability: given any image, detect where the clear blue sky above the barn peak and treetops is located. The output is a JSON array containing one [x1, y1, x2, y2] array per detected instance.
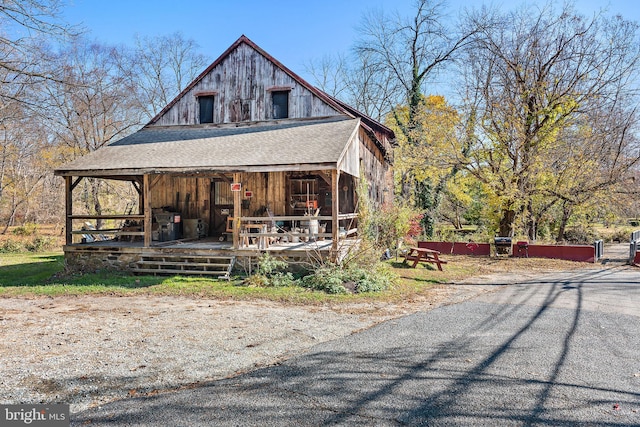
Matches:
[[63, 0, 640, 83]]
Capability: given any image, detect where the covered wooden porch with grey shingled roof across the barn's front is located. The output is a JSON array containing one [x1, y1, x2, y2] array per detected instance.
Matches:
[[56, 118, 391, 271]]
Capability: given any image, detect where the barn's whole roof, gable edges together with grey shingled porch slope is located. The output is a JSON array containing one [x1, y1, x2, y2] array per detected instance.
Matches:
[[54, 35, 394, 179]]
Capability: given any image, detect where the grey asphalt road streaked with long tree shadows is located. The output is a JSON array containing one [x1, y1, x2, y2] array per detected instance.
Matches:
[[72, 264, 640, 427]]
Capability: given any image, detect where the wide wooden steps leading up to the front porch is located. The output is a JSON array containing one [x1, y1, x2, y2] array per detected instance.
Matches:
[[135, 253, 236, 280]]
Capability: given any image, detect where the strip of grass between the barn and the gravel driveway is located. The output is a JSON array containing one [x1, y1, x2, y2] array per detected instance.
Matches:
[[0, 253, 465, 304]]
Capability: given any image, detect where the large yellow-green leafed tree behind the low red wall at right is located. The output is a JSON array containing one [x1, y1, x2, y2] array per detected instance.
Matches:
[[463, 3, 640, 238]]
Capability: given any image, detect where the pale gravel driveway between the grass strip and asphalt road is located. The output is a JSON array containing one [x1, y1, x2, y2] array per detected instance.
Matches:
[[0, 286, 491, 412]]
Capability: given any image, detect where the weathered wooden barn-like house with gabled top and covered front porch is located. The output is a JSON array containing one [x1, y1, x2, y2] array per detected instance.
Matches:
[[55, 36, 394, 274]]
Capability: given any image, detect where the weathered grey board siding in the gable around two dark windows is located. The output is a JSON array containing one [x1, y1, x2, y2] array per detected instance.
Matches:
[[155, 44, 341, 125]]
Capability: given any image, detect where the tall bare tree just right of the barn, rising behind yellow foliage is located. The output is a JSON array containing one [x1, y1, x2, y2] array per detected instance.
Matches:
[[356, 0, 475, 234]]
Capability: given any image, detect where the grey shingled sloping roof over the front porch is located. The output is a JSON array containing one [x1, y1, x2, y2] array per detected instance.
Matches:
[[55, 117, 360, 177]]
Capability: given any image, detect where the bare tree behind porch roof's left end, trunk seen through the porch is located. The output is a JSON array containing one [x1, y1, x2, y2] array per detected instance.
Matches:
[[41, 39, 144, 225]]
